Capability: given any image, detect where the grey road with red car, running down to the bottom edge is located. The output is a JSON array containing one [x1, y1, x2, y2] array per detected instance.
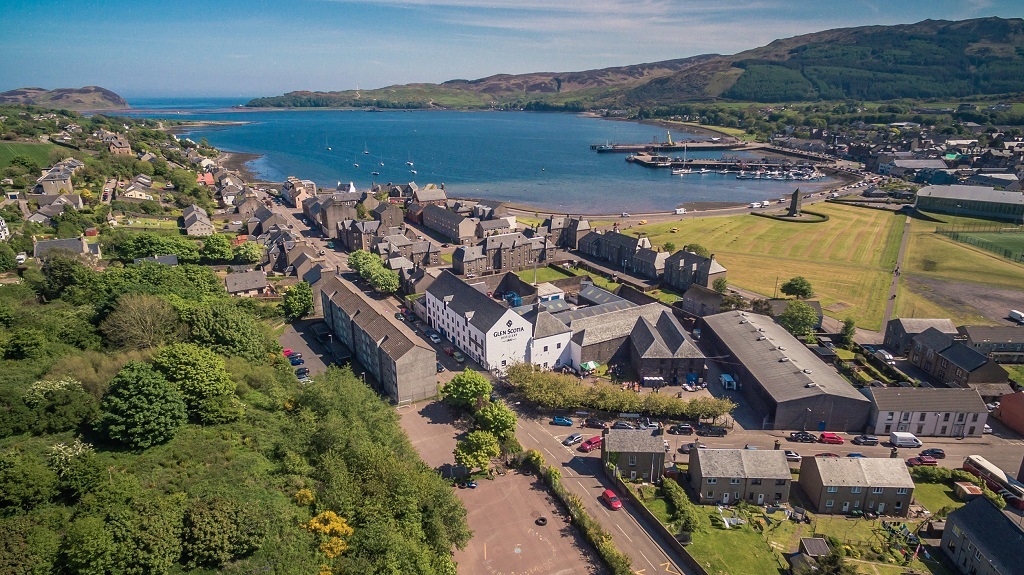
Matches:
[[516, 413, 690, 575]]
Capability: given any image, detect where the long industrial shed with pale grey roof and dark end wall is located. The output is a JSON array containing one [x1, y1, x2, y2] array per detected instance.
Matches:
[[701, 311, 870, 432]]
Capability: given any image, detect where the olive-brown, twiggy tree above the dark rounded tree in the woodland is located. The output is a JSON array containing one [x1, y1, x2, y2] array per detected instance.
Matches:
[[99, 294, 182, 349]]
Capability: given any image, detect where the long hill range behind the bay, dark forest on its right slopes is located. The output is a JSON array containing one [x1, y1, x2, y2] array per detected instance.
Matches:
[[248, 17, 1024, 109]]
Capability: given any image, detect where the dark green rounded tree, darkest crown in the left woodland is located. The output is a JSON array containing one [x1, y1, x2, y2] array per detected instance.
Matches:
[[96, 361, 187, 449]]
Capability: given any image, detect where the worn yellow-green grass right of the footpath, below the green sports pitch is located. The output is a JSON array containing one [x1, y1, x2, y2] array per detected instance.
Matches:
[[903, 210, 1024, 290]]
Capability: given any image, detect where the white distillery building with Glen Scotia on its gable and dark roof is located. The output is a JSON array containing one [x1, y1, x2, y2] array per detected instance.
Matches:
[[424, 271, 532, 372]]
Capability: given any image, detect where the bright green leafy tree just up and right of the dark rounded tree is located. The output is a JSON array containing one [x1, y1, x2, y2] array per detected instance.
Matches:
[[153, 344, 241, 423]]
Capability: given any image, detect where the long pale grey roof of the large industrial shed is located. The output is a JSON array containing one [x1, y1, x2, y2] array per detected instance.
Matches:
[[702, 311, 867, 403]]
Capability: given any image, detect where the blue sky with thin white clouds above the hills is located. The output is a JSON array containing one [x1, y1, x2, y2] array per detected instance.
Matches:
[[0, 0, 1024, 98]]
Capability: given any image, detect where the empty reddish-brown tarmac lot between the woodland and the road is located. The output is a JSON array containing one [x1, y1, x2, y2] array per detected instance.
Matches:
[[398, 402, 604, 575]]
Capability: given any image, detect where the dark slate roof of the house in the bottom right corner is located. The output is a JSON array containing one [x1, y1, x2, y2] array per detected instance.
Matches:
[[946, 497, 1024, 574]]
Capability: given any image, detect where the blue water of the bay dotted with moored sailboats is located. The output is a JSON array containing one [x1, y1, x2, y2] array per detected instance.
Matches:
[[132, 100, 835, 214]]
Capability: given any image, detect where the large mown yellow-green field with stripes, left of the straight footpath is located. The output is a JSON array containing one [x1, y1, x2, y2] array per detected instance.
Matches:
[[635, 205, 904, 329]]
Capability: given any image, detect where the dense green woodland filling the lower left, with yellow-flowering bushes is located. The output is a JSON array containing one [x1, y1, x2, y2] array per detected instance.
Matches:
[[0, 255, 470, 574]]
